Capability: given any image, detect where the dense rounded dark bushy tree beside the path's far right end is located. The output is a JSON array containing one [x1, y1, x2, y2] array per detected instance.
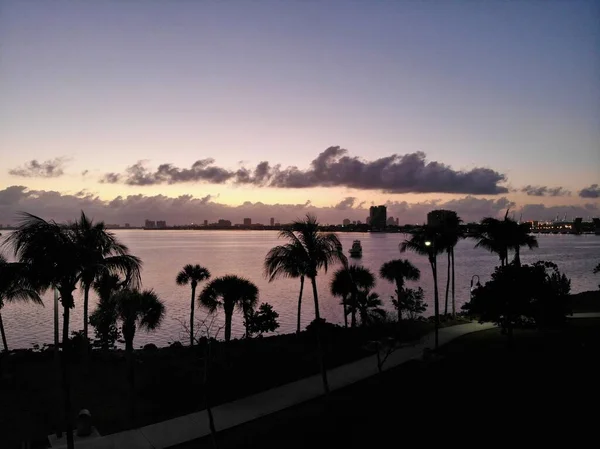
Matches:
[[463, 261, 571, 329]]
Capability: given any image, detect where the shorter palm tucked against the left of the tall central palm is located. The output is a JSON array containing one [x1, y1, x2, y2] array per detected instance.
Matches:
[[264, 240, 308, 334]]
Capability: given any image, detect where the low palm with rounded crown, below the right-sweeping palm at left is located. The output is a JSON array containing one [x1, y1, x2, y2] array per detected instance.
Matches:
[[112, 289, 165, 425]]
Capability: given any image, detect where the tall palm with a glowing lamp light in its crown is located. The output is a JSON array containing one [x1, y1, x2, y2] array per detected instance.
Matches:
[[400, 226, 444, 349]]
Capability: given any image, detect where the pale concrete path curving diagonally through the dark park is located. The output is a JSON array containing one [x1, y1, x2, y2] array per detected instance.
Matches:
[[51, 322, 494, 449]]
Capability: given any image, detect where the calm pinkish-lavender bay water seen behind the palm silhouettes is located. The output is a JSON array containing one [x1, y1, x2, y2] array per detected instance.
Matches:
[[2, 230, 600, 348]]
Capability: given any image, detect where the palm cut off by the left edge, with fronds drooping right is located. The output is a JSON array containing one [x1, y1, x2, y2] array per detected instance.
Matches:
[[0, 254, 44, 352]]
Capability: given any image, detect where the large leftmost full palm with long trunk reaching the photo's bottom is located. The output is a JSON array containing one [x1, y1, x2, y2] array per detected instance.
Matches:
[[4, 213, 85, 449]]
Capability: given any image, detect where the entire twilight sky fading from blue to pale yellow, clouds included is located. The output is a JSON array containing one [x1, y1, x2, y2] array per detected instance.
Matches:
[[0, 0, 600, 224]]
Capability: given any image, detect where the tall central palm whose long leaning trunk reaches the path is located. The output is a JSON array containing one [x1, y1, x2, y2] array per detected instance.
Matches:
[[264, 214, 348, 393]]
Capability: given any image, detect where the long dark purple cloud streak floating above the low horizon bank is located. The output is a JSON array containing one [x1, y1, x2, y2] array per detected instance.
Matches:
[[101, 146, 508, 195]]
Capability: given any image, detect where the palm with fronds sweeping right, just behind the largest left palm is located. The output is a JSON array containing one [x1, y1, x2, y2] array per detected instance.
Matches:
[[71, 211, 142, 342]]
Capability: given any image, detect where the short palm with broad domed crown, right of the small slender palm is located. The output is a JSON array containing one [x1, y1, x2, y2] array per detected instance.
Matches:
[[198, 275, 258, 341]]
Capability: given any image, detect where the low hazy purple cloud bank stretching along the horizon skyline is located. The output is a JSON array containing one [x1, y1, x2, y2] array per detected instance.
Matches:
[[0, 186, 600, 226]]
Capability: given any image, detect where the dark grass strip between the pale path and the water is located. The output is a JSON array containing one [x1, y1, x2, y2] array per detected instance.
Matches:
[[0, 321, 468, 449]]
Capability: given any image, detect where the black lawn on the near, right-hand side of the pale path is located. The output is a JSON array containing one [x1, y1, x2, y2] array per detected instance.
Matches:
[[177, 319, 600, 449]]
